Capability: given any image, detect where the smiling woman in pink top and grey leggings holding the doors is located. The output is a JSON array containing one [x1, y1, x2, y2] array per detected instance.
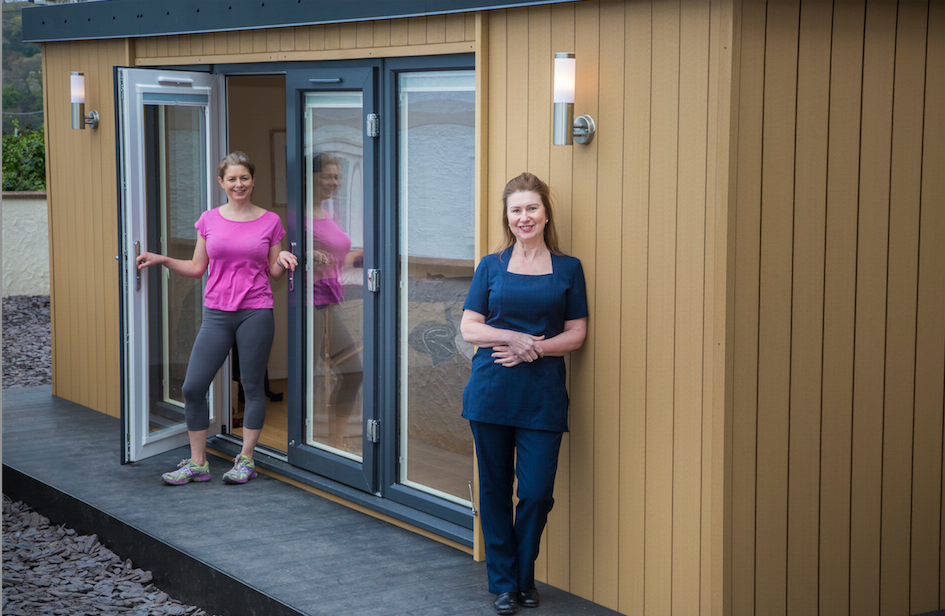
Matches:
[[138, 152, 298, 485]]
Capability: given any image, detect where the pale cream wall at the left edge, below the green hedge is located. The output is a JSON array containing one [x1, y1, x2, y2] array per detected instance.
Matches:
[[3, 192, 49, 297]]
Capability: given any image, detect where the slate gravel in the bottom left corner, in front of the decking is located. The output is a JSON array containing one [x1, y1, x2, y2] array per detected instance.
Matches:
[[3, 495, 219, 616]]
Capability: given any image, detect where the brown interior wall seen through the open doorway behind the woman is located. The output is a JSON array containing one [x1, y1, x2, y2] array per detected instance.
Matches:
[[227, 75, 289, 379]]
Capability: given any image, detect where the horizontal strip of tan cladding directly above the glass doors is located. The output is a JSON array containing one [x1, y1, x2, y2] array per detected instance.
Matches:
[[135, 13, 476, 66]]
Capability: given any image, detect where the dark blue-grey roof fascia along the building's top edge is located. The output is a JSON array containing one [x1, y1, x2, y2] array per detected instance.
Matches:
[[23, 0, 574, 43]]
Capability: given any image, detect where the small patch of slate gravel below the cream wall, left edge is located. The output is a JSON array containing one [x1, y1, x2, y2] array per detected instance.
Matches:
[[3, 295, 52, 387]]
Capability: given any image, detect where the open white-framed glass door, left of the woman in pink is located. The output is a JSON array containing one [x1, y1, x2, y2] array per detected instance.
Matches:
[[116, 68, 223, 462]]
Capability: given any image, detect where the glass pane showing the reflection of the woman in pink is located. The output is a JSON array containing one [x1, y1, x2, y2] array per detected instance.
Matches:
[[303, 92, 364, 460]]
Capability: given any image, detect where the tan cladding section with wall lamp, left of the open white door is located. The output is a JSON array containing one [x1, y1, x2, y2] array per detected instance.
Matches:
[[43, 40, 131, 417]]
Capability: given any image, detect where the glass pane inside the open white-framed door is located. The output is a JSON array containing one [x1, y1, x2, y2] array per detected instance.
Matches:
[[145, 105, 209, 432]]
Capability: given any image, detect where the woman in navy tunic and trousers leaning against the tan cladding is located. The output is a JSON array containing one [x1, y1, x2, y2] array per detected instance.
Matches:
[[461, 173, 588, 614]]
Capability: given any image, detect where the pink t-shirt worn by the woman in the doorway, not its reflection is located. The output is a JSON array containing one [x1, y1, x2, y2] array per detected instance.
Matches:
[[194, 208, 285, 311]]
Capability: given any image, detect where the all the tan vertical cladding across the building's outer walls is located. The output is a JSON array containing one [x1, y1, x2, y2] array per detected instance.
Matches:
[[43, 0, 945, 616]]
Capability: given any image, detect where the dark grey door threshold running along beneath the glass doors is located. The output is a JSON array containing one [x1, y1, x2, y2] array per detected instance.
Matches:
[[207, 436, 473, 555]]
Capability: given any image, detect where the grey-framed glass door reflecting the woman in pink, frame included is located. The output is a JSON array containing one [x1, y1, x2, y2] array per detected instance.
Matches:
[[286, 66, 381, 492]]
